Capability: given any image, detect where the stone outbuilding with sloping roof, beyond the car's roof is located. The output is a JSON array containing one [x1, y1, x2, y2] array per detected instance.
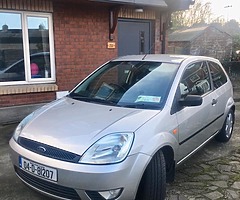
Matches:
[[168, 25, 233, 61]]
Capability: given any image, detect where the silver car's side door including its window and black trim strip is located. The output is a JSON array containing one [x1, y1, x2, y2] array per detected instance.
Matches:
[[176, 62, 214, 160]]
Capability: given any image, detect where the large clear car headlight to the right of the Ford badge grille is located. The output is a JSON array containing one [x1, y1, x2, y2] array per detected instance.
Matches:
[[79, 133, 134, 164]]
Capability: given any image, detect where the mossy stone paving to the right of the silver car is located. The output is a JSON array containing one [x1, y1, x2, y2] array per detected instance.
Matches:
[[167, 103, 240, 200]]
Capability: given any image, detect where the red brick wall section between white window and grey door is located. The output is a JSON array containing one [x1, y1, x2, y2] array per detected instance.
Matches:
[[54, 3, 117, 90]]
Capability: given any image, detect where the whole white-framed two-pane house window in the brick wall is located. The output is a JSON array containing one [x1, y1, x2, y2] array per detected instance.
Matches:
[[0, 11, 55, 85]]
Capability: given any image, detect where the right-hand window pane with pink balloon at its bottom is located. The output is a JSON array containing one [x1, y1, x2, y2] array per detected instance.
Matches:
[[27, 16, 51, 78]]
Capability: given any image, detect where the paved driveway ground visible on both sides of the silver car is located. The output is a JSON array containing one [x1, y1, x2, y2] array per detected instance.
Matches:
[[0, 104, 240, 200]]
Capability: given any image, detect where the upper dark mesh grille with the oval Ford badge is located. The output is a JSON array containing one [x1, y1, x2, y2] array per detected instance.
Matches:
[[18, 137, 81, 163]]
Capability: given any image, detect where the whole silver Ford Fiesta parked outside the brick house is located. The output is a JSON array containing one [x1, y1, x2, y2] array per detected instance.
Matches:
[[10, 55, 235, 200]]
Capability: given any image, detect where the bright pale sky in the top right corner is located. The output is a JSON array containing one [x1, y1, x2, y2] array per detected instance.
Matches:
[[201, 0, 240, 22]]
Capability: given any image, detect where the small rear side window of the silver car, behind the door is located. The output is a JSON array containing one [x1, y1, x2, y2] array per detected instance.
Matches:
[[208, 61, 227, 89]]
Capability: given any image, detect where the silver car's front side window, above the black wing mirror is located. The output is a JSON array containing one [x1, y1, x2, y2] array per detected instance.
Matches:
[[179, 62, 211, 97]]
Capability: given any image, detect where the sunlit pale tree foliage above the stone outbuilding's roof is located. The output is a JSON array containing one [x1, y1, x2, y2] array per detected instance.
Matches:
[[171, 0, 212, 27]]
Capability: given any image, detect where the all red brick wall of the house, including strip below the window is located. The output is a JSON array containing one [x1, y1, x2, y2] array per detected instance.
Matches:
[[0, 0, 167, 107]]
